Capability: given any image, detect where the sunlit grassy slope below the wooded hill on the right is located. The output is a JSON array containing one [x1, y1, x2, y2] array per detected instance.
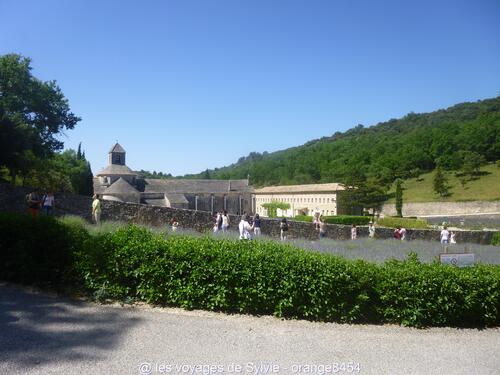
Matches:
[[389, 164, 500, 203]]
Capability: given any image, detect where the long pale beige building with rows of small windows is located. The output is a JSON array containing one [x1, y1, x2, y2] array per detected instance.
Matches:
[[254, 183, 344, 217]]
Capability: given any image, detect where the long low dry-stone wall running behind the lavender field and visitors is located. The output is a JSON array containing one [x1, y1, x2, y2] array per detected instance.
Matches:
[[0, 184, 494, 244]]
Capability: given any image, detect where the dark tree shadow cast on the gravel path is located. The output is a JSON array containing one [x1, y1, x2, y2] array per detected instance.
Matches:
[[0, 283, 140, 368]]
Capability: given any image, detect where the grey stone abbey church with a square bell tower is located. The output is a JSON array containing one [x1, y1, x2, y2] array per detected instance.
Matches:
[[94, 143, 255, 214]]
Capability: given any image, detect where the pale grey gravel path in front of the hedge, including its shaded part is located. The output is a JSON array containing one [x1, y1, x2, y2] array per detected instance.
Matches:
[[0, 284, 500, 375]]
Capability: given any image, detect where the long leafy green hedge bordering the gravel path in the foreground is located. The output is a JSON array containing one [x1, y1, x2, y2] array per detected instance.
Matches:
[[0, 216, 500, 326]]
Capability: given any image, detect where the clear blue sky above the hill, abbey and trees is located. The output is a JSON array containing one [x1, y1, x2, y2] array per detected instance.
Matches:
[[0, 0, 500, 175]]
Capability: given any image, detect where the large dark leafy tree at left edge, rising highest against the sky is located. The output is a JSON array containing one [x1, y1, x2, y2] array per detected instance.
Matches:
[[0, 54, 80, 181]]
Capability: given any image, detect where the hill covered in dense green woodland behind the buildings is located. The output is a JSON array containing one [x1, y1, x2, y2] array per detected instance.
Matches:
[[184, 96, 500, 186]]
